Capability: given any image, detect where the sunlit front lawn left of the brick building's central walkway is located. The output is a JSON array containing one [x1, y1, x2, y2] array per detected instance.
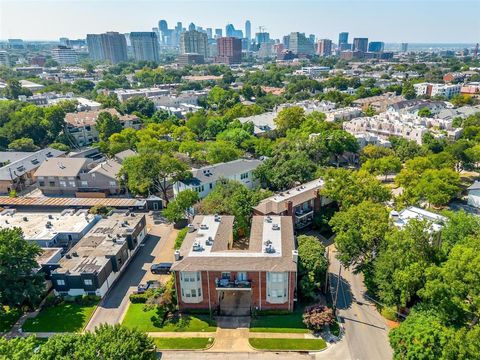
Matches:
[[122, 304, 217, 332]]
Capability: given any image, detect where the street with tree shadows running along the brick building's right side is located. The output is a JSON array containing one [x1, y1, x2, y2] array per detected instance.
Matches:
[[322, 245, 393, 360]]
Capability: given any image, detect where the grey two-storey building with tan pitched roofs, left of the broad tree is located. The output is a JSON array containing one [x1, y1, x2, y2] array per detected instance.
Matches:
[[34, 158, 122, 197]]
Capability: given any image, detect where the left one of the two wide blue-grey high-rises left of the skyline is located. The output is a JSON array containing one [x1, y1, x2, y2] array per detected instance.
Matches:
[[87, 31, 128, 64]]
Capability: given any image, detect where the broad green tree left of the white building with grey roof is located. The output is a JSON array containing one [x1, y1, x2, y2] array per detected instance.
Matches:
[[120, 153, 191, 203]]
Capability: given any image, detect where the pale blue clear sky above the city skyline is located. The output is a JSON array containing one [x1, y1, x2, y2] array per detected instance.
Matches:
[[0, 0, 480, 43]]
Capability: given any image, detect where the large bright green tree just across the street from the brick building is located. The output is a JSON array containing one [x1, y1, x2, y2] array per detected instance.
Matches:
[[374, 219, 440, 307]]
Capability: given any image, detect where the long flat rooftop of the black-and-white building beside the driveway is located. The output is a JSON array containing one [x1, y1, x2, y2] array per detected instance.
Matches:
[[55, 212, 145, 275]]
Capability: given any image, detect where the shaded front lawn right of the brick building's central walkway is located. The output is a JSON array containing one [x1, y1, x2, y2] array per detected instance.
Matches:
[[250, 306, 310, 333]]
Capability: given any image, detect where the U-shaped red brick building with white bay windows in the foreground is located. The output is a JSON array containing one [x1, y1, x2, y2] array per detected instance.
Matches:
[[172, 215, 298, 315]]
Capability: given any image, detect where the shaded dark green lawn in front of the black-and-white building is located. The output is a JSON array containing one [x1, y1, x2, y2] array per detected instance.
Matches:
[[23, 302, 96, 332]]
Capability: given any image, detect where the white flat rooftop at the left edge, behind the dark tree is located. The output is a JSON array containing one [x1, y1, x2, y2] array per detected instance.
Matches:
[[0, 209, 98, 240]]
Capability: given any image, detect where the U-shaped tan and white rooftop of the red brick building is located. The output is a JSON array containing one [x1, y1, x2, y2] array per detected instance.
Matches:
[[172, 215, 297, 271]]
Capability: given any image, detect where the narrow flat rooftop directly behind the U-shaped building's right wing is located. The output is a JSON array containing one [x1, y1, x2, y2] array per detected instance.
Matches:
[[254, 178, 324, 214]]
